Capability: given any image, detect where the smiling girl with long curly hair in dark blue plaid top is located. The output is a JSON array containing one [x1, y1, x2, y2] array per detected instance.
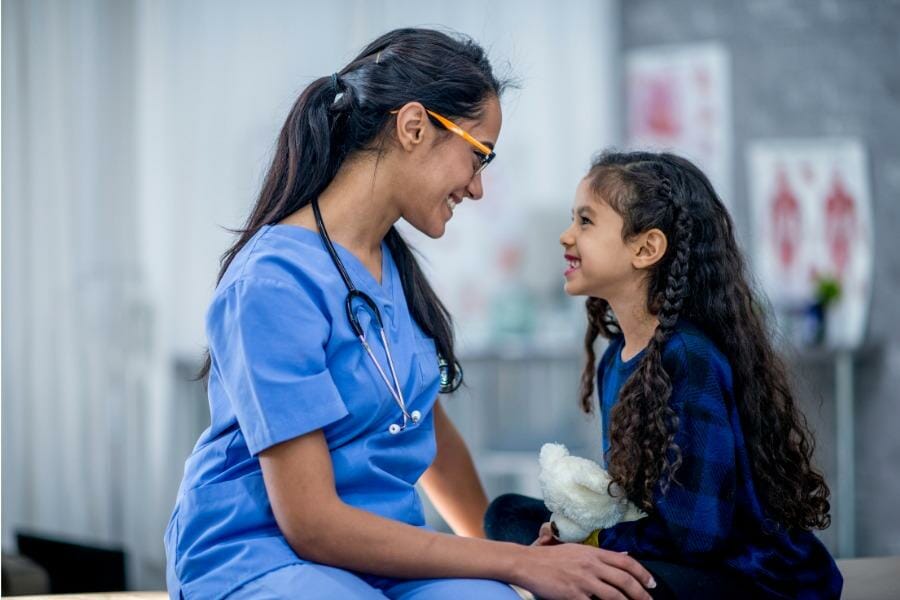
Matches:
[[486, 152, 842, 598]]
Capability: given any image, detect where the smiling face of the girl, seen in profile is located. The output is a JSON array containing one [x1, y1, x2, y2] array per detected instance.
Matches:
[[559, 179, 639, 300]]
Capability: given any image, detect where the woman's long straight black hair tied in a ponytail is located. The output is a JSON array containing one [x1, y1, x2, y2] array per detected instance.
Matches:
[[198, 29, 506, 381]]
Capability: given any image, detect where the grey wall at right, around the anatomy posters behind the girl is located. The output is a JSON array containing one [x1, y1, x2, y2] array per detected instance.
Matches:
[[622, 0, 900, 556]]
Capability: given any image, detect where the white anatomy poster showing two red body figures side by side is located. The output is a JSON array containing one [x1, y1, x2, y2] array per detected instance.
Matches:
[[747, 139, 873, 348]]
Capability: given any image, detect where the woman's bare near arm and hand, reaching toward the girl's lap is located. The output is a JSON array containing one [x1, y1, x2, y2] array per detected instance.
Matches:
[[260, 430, 652, 600]]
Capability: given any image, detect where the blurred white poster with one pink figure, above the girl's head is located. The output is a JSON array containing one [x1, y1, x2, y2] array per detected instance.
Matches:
[[625, 44, 732, 203]]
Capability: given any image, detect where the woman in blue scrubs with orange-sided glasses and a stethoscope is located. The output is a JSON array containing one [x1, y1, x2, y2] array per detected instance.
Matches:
[[165, 29, 652, 599]]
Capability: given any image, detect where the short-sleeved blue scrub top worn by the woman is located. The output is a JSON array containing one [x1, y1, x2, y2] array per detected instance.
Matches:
[[165, 225, 439, 598]]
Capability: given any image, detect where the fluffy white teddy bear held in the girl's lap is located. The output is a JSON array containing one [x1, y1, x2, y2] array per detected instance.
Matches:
[[538, 444, 647, 546]]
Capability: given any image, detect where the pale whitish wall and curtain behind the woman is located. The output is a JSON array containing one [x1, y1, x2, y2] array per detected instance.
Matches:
[[2, 0, 619, 588]]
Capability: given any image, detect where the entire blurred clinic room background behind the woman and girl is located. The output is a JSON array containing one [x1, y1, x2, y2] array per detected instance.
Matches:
[[2, 0, 900, 592]]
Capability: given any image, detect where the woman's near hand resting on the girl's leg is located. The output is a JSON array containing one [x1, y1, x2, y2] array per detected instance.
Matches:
[[514, 544, 656, 600]]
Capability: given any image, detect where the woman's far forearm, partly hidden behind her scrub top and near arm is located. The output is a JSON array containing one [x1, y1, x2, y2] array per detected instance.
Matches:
[[419, 402, 488, 538]]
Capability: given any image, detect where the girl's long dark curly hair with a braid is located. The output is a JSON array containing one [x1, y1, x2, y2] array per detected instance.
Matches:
[[581, 152, 830, 529]]
